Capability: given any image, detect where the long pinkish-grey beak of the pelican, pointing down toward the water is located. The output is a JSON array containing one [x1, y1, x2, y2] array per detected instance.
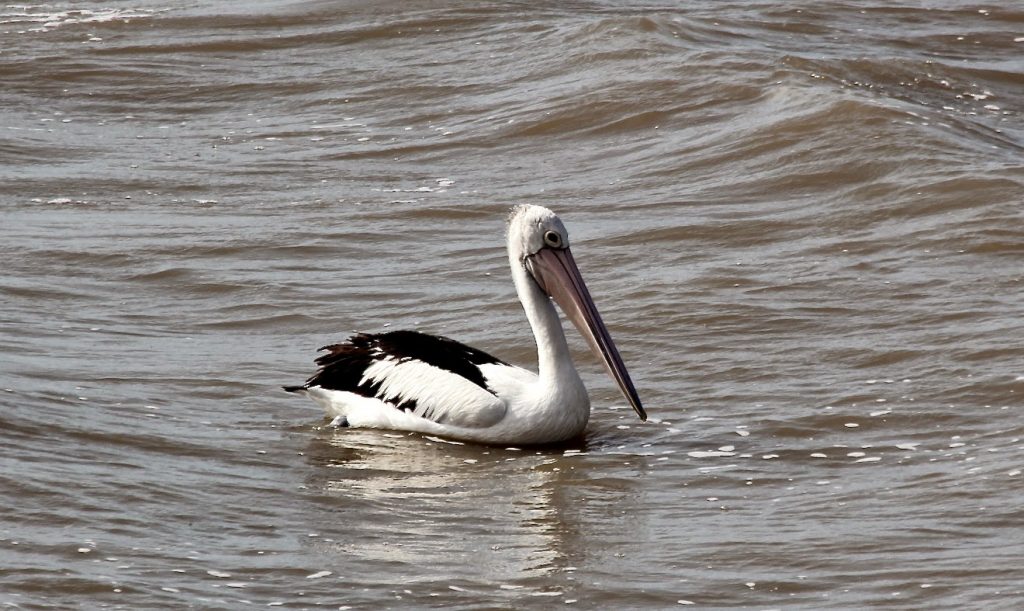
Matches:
[[526, 248, 647, 421]]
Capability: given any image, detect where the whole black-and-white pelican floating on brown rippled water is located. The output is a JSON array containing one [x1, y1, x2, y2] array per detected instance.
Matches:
[[285, 206, 647, 444]]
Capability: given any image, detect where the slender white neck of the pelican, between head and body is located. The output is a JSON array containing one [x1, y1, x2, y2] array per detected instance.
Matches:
[[509, 253, 580, 385]]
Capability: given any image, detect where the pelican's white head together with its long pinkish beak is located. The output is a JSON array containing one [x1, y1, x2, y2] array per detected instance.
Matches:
[[508, 206, 647, 420]]
